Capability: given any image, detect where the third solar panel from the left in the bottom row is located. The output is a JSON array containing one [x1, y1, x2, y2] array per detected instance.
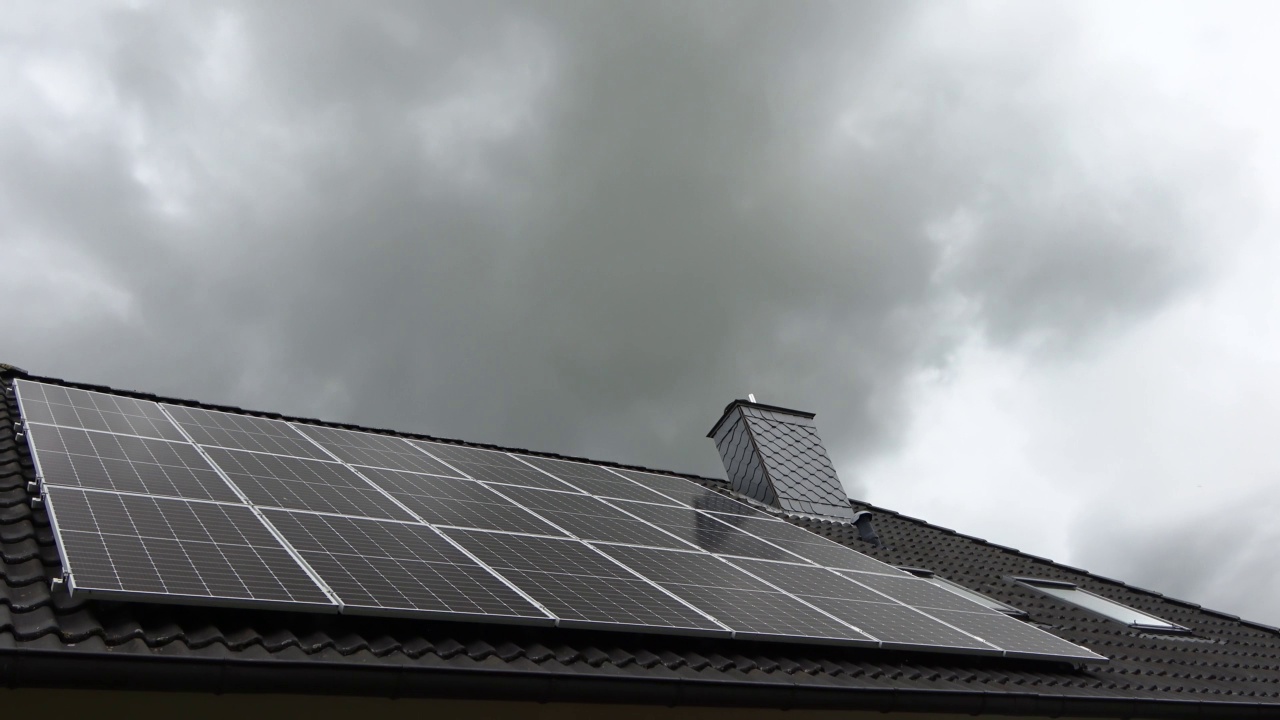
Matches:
[[444, 529, 727, 634]]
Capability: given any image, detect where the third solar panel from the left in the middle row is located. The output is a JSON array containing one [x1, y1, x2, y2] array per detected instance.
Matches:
[[361, 468, 562, 536]]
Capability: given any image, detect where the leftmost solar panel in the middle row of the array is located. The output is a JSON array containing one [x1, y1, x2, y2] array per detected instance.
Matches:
[[27, 423, 239, 502]]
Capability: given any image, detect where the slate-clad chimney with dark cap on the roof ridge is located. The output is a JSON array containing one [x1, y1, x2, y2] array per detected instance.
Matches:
[[707, 400, 854, 521]]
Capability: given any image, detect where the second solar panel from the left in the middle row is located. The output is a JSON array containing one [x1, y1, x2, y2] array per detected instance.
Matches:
[[205, 447, 413, 520]]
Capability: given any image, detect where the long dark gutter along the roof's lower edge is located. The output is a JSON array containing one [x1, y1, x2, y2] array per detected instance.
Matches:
[[0, 650, 1280, 720]]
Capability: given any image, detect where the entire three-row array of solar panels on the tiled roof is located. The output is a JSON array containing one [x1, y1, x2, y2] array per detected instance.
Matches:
[[15, 379, 1102, 661]]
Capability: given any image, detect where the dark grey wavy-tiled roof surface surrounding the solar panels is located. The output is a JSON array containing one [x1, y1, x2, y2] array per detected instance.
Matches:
[[0, 368, 1280, 717]]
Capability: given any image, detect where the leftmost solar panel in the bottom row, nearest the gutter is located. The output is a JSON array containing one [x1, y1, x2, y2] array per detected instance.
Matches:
[[45, 487, 335, 610]]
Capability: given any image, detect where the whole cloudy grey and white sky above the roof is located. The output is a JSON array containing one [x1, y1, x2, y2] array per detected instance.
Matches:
[[0, 1, 1280, 624]]
